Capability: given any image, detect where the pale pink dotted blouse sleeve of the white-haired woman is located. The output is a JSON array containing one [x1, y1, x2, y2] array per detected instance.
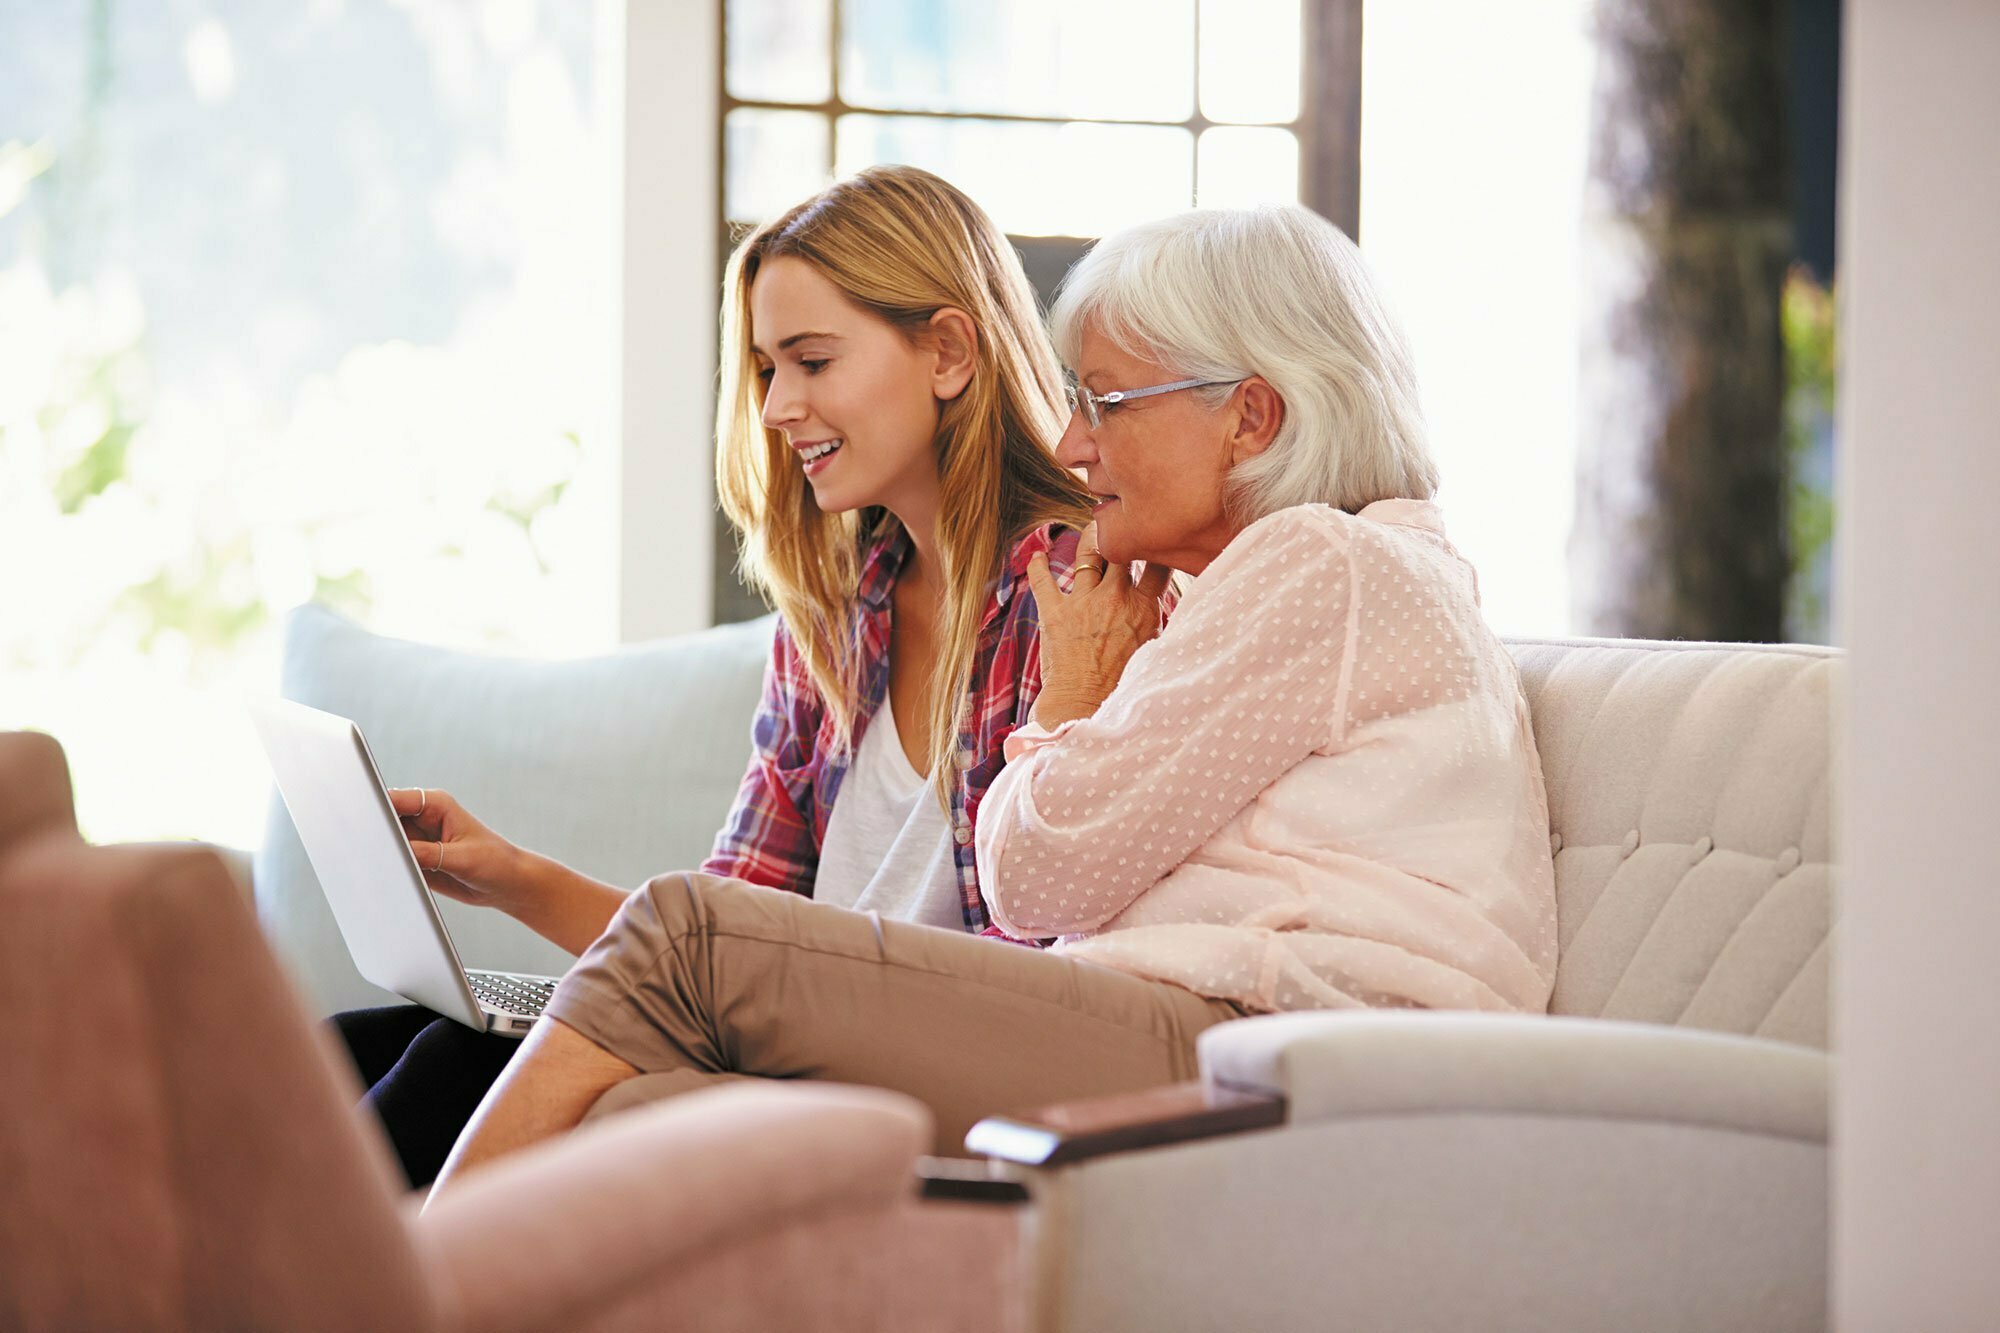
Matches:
[[978, 508, 1354, 937]]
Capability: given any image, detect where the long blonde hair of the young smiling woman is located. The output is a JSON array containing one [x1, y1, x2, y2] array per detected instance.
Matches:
[[716, 166, 1090, 811]]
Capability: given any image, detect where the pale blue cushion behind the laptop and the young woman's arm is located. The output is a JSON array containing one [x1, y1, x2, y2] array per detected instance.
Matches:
[[254, 606, 774, 1013]]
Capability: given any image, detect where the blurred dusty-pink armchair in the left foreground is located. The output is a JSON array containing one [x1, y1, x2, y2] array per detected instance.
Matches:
[[0, 733, 1028, 1331]]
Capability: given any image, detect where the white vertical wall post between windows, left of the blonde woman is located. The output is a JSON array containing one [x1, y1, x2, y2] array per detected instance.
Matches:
[[604, 0, 722, 642]]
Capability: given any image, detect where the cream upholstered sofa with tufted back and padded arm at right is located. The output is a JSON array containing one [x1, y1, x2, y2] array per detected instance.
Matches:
[[968, 642, 1838, 1333]]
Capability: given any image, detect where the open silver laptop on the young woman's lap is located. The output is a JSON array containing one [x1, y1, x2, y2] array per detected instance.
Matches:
[[250, 699, 558, 1037]]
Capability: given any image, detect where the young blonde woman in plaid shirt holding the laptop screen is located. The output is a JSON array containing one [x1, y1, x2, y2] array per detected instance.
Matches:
[[336, 166, 1090, 1185]]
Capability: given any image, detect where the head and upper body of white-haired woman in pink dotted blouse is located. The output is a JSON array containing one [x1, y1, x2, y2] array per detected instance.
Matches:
[[978, 206, 1556, 1011]]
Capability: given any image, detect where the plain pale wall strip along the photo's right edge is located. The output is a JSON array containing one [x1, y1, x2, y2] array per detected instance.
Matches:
[[1832, 0, 2000, 1329]]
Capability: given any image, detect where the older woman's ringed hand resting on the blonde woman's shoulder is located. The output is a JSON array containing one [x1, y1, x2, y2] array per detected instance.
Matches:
[[1028, 524, 1174, 727]]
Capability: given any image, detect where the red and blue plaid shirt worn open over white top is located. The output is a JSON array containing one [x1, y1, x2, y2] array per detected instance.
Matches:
[[702, 522, 1078, 935]]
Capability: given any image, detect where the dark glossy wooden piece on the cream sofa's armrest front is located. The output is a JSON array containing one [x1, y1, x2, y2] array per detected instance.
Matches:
[[966, 1081, 1284, 1167]]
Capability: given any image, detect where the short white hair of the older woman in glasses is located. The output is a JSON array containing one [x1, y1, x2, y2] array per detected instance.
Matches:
[[1052, 204, 1438, 524]]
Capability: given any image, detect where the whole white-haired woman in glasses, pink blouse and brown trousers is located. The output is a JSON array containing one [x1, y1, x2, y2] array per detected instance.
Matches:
[[438, 208, 1556, 1189]]
